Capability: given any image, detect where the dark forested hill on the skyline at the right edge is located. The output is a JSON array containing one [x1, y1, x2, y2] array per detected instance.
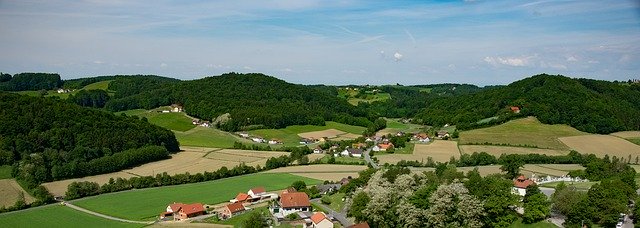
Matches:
[[415, 74, 640, 133]]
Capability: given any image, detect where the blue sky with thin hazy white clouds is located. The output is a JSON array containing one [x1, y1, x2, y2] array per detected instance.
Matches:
[[0, 0, 640, 85]]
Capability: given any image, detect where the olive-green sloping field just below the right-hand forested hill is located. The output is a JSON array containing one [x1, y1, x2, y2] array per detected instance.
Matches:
[[460, 117, 588, 150]]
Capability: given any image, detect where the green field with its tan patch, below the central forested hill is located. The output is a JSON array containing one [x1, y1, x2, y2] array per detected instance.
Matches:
[[249, 121, 365, 146]]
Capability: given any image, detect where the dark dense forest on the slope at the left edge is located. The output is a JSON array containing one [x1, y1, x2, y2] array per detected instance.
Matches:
[[0, 92, 179, 184]]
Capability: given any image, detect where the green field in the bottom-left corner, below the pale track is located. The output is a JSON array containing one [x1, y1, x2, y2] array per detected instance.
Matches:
[[0, 205, 145, 227]]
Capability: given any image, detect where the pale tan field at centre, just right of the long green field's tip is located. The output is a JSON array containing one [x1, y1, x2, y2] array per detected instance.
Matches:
[[266, 164, 367, 181]]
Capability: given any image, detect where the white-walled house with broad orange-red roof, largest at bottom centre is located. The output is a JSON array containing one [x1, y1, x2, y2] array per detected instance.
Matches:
[[270, 192, 311, 220]]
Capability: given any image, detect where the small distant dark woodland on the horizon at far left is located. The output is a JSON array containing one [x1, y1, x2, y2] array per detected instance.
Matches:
[[0, 73, 62, 91]]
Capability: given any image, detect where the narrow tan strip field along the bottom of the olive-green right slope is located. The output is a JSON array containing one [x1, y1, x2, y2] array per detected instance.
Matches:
[[460, 145, 569, 158]]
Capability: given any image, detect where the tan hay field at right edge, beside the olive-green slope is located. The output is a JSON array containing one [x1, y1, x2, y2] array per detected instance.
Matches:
[[560, 135, 640, 158]]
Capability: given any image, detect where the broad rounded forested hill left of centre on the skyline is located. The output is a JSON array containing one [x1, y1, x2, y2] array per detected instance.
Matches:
[[105, 73, 371, 131]]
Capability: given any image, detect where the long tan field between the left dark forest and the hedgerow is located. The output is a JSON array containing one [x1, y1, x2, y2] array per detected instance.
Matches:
[[43, 147, 289, 196]]
